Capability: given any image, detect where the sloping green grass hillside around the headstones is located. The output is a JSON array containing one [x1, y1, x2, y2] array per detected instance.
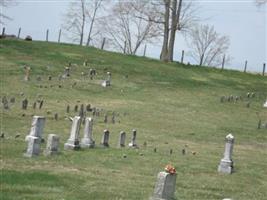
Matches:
[[0, 40, 267, 200]]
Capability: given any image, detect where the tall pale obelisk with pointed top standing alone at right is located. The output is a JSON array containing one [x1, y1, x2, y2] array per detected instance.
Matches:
[[218, 133, 234, 174]]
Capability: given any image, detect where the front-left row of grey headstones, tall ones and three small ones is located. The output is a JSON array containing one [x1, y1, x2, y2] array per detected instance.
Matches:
[[24, 116, 138, 157]]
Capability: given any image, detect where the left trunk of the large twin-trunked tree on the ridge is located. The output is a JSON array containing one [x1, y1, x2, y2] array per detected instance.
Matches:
[[160, 0, 170, 61]]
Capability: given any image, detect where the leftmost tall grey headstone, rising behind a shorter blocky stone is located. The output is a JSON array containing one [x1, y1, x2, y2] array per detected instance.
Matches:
[[25, 116, 45, 142]]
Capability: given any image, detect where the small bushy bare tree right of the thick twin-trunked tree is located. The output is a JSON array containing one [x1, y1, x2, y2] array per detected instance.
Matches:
[[188, 25, 230, 66]]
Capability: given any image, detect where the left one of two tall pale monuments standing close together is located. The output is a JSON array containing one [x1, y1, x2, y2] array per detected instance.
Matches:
[[64, 116, 81, 150]]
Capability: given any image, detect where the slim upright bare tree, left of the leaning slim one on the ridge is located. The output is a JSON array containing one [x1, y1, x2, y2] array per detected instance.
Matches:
[[62, 0, 86, 45]]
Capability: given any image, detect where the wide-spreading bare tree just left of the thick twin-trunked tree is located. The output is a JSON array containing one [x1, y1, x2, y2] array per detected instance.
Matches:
[[101, 0, 160, 54]]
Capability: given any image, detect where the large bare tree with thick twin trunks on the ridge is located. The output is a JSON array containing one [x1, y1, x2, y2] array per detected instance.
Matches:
[[132, 0, 198, 61]]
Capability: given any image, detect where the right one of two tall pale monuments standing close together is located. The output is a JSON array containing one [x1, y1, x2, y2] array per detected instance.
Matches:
[[81, 117, 95, 148]]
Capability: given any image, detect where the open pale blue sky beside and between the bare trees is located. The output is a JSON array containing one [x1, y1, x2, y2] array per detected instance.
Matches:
[[1, 0, 267, 72]]
